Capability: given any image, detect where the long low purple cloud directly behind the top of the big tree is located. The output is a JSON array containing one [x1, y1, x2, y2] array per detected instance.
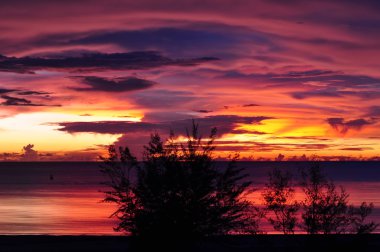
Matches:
[[55, 115, 271, 158]]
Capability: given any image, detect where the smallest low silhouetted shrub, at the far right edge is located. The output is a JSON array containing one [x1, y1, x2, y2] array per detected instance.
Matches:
[[349, 202, 379, 234]]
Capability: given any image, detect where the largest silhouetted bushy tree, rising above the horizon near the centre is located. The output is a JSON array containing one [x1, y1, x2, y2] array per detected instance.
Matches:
[[102, 123, 255, 238]]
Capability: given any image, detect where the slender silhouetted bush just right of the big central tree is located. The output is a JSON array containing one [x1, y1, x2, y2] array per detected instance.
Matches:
[[262, 168, 299, 234]]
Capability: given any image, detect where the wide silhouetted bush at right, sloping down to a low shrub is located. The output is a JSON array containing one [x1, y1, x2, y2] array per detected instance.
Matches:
[[302, 163, 378, 234]]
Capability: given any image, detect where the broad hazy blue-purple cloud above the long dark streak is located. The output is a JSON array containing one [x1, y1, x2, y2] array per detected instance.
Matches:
[[8, 22, 279, 59]]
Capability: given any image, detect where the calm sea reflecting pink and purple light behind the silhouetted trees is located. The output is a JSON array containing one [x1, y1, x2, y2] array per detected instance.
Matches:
[[0, 162, 380, 235]]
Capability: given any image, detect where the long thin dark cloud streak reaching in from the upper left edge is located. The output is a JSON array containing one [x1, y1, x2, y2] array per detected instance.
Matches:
[[0, 51, 217, 73]]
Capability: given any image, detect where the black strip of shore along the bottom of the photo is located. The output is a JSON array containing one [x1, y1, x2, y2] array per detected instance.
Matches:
[[0, 234, 380, 252]]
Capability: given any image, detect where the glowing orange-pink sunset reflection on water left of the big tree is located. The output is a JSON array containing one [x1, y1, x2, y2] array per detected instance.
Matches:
[[0, 185, 117, 235]]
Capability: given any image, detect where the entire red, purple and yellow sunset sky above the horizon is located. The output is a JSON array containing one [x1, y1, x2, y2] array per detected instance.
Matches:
[[0, 0, 380, 161]]
